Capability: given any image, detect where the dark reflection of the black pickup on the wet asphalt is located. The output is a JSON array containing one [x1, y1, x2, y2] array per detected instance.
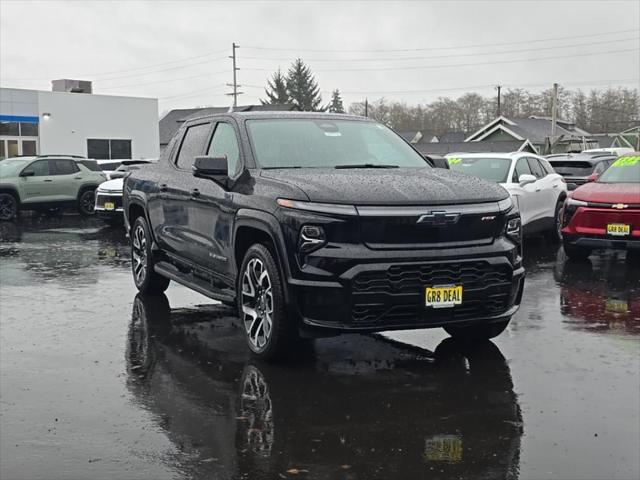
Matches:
[[126, 295, 523, 480]]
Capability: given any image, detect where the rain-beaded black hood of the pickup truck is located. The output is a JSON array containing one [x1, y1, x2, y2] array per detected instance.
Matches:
[[261, 168, 509, 205]]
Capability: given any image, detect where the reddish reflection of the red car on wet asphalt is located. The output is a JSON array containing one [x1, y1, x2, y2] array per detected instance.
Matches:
[[555, 252, 640, 335]]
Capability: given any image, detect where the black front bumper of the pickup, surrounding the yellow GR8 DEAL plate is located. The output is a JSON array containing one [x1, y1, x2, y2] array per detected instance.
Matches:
[[288, 242, 524, 332]]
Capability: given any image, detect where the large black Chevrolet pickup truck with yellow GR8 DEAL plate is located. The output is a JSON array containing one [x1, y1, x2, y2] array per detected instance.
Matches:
[[123, 112, 524, 358]]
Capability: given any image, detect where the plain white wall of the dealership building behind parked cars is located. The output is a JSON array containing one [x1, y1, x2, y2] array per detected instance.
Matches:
[[37, 91, 160, 158]]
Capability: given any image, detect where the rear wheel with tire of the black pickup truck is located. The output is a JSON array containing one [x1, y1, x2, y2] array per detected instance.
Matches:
[[131, 216, 170, 294]]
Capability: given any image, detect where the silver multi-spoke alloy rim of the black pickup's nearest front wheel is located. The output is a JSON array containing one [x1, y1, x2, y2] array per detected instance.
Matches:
[[242, 258, 273, 350]]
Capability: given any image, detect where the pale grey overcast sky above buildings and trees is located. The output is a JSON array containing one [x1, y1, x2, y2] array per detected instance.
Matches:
[[0, 0, 640, 116]]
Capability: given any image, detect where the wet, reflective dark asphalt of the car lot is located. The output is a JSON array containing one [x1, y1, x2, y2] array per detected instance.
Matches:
[[0, 217, 640, 480]]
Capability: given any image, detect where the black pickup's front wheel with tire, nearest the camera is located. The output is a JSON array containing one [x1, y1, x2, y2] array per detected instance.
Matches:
[[237, 244, 298, 360]]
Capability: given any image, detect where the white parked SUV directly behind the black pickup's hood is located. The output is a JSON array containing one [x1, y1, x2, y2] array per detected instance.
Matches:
[[447, 152, 567, 240]]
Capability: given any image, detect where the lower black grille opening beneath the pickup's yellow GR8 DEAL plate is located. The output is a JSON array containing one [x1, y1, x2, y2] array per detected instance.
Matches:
[[351, 293, 509, 326]]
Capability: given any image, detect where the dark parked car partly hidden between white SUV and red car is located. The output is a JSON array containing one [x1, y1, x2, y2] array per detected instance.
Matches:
[[546, 153, 618, 190]]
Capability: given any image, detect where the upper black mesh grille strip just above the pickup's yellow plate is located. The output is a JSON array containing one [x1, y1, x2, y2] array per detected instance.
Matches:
[[353, 262, 512, 293]]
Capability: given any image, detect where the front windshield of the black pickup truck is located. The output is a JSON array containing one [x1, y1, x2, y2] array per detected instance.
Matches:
[[247, 118, 430, 168]]
